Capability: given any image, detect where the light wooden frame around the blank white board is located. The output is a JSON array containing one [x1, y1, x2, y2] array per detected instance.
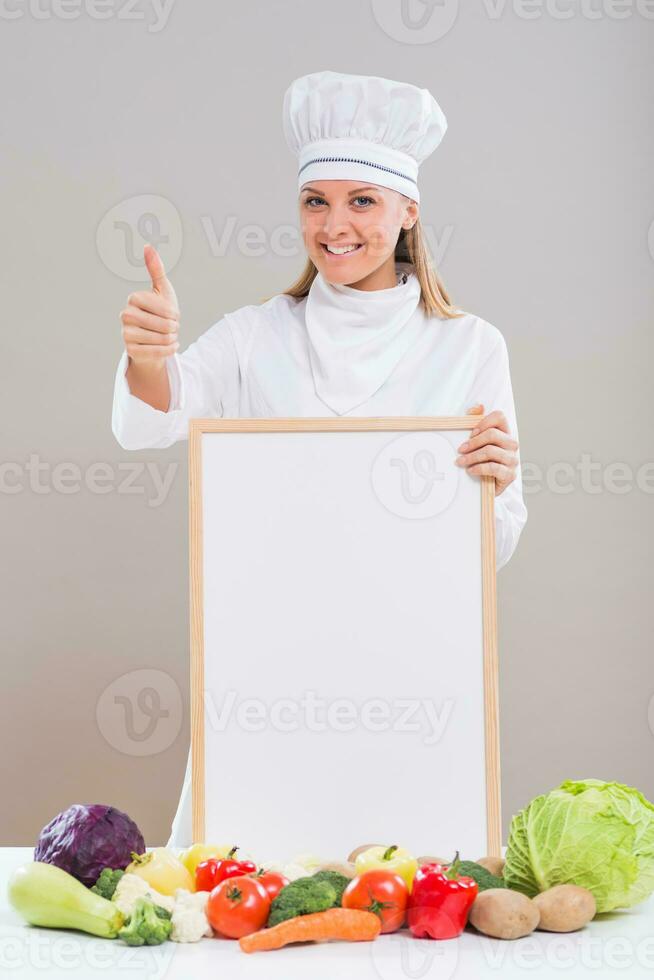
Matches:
[[189, 416, 501, 856]]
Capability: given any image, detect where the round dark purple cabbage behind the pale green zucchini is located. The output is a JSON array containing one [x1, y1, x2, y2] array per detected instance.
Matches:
[[34, 803, 145, 888]]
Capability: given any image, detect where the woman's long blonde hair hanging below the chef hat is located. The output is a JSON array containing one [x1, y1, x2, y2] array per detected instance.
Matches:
[[283, 218, 465, 319]]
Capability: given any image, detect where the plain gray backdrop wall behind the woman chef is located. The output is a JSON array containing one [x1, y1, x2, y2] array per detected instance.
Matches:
[[0, 0, 654, 846]]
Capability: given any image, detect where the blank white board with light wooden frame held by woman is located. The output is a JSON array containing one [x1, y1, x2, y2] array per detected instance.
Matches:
[[190, 417, 500, 860]]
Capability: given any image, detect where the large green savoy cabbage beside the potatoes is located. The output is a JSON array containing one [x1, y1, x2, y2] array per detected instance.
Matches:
[[504, 779, 654, 912]]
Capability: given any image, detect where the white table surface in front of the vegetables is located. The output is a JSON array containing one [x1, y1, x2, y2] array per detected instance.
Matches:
[[0, 847, 654, 980]]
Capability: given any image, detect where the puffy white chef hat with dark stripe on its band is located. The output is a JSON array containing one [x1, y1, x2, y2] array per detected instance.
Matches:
[[282, 71, 447, 201]]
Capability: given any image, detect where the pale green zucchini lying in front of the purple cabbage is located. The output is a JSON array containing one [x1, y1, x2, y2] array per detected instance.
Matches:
[[8, 861, 125, 939]]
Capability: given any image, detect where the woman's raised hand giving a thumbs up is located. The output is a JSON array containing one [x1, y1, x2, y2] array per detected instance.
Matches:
[[120, 245, 179, 371]]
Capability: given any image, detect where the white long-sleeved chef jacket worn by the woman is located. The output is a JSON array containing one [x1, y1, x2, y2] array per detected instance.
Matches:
[[112, 293, 527, 847]]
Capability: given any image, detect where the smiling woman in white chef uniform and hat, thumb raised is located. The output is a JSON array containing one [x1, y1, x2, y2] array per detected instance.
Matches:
[[112, 71, 527, 847]]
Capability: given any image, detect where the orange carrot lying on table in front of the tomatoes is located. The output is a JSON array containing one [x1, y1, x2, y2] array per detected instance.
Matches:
[[239, 908, 381, 953]]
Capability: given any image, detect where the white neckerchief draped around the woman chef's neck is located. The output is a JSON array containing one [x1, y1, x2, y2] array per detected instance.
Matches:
[[305, 262, 423, 415]]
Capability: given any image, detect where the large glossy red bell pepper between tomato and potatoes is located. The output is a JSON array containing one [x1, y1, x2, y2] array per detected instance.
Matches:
[[407, 851, 479, 939]]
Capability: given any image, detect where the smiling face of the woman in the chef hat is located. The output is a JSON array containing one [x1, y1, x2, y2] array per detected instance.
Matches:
[[300, 180, 418, 289]]
